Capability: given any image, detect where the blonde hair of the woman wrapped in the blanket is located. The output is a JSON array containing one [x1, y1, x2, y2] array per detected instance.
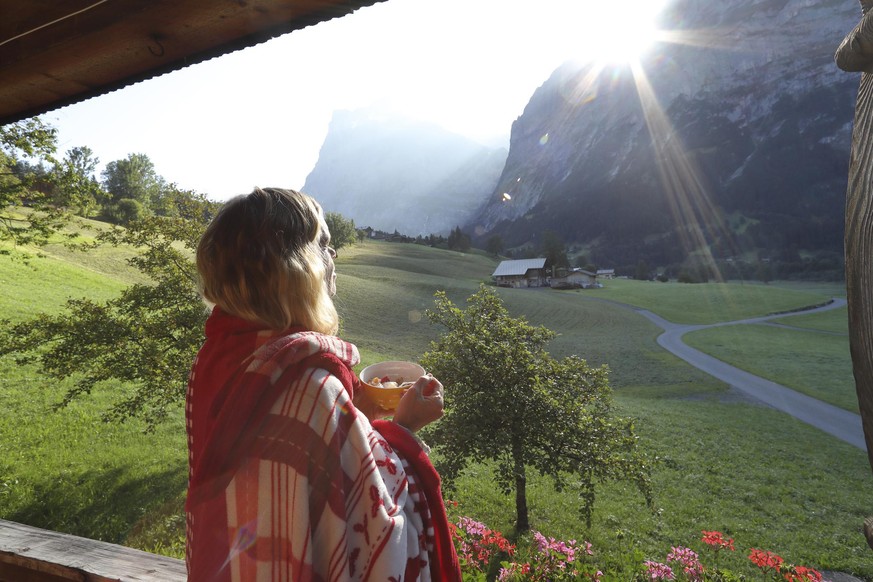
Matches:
[[197, 188, 339, 334]]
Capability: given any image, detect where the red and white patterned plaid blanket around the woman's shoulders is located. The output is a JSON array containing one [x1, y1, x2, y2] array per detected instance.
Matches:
[[186, 308, 460, 582]]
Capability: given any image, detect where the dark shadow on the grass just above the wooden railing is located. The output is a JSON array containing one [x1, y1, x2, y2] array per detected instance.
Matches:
[[7, 464, 188, 553]]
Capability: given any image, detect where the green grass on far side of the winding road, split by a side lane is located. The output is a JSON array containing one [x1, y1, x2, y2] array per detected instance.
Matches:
[[586, 280, 858, 412]]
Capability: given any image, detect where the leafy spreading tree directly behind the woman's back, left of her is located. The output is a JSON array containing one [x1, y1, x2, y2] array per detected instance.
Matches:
[[0, 191, 218, 428]]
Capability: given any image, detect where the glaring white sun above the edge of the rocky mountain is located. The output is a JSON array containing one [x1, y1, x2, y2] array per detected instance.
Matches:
[[561, 0, 668, 65]]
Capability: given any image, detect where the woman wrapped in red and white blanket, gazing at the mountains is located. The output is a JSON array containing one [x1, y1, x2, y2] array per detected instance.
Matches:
[[186, 188, 460, 582]]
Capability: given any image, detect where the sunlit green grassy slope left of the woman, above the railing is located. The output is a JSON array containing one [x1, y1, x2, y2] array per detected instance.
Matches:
[[0, 237, 187, 555]]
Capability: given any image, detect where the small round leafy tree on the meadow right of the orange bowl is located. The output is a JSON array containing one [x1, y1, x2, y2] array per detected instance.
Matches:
[[421, 285, 651, 532]]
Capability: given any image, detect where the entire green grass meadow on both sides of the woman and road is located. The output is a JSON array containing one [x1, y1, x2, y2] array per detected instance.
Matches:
[[0, 242, 873, 581]]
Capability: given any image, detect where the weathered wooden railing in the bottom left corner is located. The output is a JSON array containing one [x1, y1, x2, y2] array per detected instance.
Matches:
[[0, 519, 188, 582]]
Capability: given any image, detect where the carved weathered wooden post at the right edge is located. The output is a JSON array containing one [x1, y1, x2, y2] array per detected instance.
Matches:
[[835, 0, 873, 548]]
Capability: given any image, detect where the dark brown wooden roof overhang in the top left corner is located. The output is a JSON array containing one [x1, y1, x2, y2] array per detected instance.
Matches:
[[0, 0, 383, 125]]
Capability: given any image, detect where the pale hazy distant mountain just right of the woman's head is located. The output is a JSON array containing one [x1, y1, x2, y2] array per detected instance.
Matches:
[[303, 109, 507, 236]]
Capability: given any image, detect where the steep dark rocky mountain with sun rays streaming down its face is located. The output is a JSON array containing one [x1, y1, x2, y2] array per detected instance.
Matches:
[[467, 0, 861, 280]]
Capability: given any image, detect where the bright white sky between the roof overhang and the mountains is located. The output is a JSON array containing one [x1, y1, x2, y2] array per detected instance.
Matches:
[[42, 0, 669, 200]]
